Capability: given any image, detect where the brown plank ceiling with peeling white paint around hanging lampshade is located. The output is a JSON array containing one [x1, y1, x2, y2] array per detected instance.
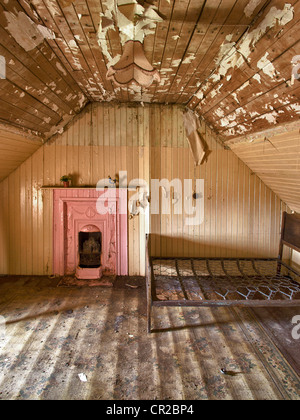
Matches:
[[0, 0, 300, 138]]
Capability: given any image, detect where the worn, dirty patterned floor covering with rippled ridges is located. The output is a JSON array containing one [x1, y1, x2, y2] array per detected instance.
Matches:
[[0, 277, 300, 400]]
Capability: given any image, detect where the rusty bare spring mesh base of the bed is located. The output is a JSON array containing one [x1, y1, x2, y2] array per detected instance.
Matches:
[[152, 258, 300, 301]]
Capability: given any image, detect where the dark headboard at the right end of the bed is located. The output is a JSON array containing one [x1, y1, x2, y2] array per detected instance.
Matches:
[[279, 212, 300, 259]]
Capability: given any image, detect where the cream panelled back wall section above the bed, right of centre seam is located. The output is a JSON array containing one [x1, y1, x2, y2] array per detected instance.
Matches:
[[151, 108, 290, 258]]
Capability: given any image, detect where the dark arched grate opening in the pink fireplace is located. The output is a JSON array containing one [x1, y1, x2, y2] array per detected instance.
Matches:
[[78, 232, 102, 268]]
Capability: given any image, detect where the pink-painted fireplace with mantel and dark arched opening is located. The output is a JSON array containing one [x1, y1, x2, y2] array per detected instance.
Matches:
[[53, 188, 128, 279]]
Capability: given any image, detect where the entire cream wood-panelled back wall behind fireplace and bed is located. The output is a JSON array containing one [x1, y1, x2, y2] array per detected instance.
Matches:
[[0, 104, 286, 275]]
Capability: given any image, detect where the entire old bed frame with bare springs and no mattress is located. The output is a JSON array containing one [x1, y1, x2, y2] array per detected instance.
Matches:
[[146, 212, 300, 333]]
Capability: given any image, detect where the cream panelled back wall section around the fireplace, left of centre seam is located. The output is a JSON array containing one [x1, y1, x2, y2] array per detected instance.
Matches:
[[0, 104, 151, 275]]
